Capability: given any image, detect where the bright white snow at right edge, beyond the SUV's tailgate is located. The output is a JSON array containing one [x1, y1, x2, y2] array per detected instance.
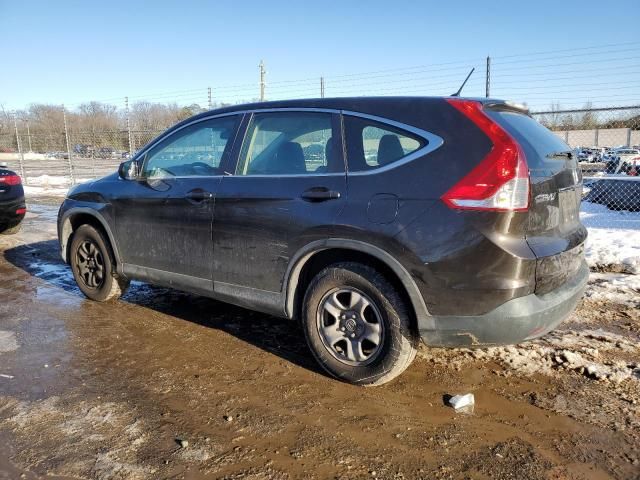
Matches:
[[580, 202, 640, 275]]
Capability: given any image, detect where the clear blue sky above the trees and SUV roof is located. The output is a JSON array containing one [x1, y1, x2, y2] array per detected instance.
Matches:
[[0, 0, 640, 109]]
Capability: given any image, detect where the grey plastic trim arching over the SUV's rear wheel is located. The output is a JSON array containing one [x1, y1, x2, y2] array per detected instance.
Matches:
[[285, 239, 429, 326]]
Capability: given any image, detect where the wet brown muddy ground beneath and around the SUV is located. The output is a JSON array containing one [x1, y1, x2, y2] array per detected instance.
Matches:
[[0, 198, 640, 479]]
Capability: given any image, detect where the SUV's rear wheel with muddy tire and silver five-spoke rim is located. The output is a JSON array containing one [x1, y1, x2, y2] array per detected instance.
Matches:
[[302, 262, 418, 386]]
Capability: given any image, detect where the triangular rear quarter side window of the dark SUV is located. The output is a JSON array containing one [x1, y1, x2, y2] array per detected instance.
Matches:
[[344, 115, 427, 172]]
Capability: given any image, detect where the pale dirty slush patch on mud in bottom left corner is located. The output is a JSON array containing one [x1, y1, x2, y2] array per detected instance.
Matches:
[[0, 396, 158, 480]]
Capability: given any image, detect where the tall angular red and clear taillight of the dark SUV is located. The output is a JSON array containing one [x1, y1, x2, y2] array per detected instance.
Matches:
[[441, 98, 529, 211]]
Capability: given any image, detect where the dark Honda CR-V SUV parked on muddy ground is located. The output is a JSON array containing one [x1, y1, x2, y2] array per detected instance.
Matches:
[[58, 97, 588, 385]]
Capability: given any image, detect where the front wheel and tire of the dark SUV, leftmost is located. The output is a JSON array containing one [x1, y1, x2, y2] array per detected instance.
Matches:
[[69, 225, 129, 302]]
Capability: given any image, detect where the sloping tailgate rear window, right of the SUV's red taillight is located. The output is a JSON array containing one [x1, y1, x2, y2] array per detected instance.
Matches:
[[487, 110, 568, 157]]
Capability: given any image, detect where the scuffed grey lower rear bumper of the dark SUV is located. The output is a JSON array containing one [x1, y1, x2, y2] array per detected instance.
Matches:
[[418, 260, 589, 347]]
